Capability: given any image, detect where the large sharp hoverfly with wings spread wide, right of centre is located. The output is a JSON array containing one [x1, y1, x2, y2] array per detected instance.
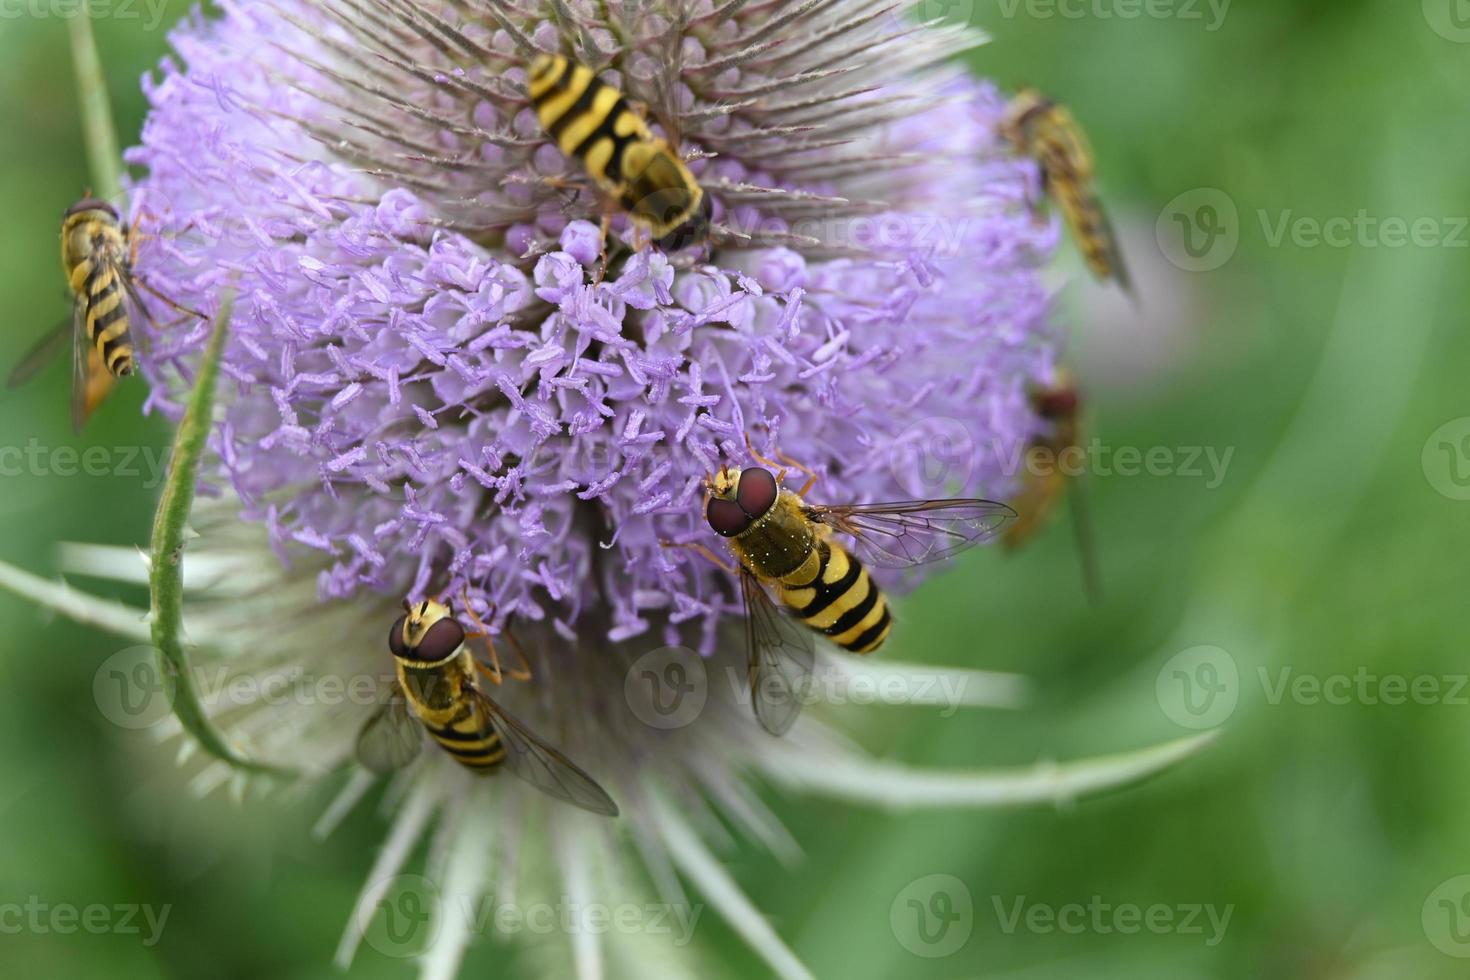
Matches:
[[704, 451, 1016, 735]]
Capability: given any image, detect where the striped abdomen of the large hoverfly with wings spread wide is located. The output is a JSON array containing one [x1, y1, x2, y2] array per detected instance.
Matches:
[[778, 541, 894, 654]]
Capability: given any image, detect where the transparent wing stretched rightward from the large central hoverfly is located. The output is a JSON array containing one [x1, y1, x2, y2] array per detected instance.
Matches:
[[804, 500, 1016, 569]]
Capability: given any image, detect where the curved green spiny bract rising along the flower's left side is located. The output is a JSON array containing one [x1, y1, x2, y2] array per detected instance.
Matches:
[[148, 292, 291, 777]]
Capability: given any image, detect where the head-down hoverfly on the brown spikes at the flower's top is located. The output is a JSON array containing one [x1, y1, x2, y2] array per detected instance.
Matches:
[[528, 54, 711, 251]]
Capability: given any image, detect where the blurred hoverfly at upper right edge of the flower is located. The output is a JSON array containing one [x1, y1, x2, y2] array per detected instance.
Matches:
[[1001, 88, 1133, 292]]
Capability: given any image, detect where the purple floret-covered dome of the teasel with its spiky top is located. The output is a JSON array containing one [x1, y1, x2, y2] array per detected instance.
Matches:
[[129, 0, 1054, 651]]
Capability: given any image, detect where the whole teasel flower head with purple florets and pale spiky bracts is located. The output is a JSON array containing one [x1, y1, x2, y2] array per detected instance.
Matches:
[[5, 0, 1195, 977]]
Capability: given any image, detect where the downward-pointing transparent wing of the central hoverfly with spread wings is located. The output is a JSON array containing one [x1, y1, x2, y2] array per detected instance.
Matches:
[[739, 569, 816, 735]]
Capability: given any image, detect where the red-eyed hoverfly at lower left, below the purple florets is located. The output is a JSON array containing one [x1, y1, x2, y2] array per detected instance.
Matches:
[[357, 599, 617, 817]]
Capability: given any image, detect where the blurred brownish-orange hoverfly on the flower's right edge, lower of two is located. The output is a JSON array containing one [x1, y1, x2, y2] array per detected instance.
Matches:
[[1003, 369, 1103, 602]]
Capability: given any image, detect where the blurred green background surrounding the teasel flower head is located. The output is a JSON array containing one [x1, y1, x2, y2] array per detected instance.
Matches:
[[0, 0, 1470, 980]]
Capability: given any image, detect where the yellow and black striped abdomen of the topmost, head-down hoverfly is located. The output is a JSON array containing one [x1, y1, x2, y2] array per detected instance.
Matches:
[[531, 54, 654, 195]]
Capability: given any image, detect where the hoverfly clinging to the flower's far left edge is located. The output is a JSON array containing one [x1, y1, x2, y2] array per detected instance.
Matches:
[[9, 197, 147, 432]]
